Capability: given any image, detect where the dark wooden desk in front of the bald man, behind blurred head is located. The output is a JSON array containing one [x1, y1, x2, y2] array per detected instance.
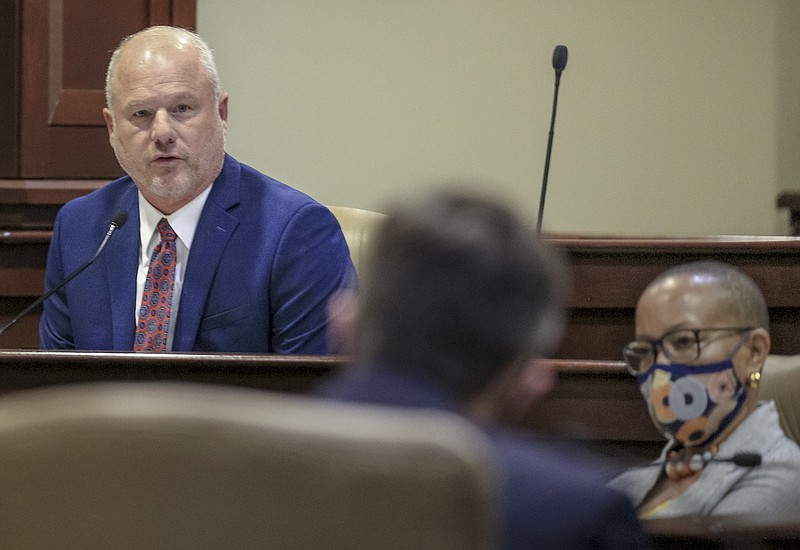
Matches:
[[0, 350, 663, 448]]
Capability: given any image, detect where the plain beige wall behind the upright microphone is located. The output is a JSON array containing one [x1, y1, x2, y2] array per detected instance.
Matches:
[[198, 0, 800, 235]]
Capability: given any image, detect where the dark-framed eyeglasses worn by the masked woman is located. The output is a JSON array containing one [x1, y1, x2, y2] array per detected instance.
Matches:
[[622, 327, 754, 376]]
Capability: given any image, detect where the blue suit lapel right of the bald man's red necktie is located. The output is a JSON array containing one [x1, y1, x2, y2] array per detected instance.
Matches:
[[172, 155, 240, 351]]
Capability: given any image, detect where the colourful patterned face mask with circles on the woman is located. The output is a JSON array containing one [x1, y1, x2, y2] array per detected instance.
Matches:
[[636, 357, 747, 447]]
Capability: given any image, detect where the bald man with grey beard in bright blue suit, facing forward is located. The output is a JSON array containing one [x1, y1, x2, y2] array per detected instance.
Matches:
[[39, 27, 355, 354]]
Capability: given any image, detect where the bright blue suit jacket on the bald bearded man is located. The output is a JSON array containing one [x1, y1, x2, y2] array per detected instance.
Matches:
[[39, 155, 355, 354]]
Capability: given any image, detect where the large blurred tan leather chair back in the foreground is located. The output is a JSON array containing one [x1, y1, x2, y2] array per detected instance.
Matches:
[[0, 383, 495, 550]]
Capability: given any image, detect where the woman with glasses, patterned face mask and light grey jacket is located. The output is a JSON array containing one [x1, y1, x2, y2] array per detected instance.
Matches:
[[610, 262, 800, 519]]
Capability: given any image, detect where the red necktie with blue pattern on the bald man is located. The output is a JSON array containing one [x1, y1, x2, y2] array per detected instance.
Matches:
[[133, 218, 177, 352]]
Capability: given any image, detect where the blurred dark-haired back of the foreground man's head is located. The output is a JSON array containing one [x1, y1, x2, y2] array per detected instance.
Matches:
[[355, 192, 566, 398]]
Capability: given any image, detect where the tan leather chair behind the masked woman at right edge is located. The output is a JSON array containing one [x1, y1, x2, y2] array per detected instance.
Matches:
[[759, 355, 800, 443]]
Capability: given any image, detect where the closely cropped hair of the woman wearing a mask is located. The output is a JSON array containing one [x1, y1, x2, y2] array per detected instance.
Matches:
[[648, 260, 769, 330]]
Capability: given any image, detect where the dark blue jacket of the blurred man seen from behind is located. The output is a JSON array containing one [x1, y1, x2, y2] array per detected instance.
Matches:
[[316, 365, 649, 550]]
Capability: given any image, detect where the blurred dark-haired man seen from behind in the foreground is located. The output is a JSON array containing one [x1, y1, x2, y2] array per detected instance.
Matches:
[[317, 193, 647, 550]]
